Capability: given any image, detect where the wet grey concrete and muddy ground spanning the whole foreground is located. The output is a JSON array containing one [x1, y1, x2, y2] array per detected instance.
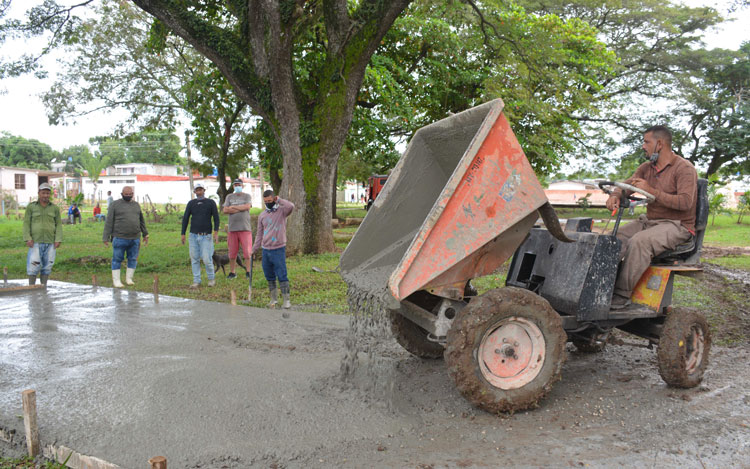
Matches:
[[0, 281, 750, 469]]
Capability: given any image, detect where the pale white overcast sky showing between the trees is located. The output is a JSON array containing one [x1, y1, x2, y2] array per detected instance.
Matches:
[[0, 0, 750, 155]]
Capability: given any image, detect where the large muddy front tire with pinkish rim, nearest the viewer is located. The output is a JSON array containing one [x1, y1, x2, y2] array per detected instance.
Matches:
[[445, 287, 567, 413]]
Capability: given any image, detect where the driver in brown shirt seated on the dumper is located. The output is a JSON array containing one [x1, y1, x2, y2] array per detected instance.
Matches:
[[607, 125, 698, 309]]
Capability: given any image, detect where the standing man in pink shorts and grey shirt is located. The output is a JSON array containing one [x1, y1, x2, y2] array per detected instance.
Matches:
[[224, 179, 253, 278]]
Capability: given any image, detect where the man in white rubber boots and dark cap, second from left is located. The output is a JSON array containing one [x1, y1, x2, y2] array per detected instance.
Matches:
[[102, 186, 148, 288]]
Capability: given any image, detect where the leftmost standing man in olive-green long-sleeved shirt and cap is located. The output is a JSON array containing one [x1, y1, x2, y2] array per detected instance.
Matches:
[[23, 183, 62, 285]]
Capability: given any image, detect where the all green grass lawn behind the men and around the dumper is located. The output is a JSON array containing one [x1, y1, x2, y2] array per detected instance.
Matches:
[[0, 204, 750, 342]]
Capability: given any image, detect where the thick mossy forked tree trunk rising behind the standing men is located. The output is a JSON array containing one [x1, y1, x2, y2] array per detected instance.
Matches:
[[133, 0, 410, 253]]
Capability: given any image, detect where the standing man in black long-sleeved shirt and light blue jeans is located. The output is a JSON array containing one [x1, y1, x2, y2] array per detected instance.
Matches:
[[182, 183, 219, 289]]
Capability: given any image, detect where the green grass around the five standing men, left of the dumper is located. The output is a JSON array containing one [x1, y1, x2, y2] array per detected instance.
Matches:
[[0, 209, 355, 314]]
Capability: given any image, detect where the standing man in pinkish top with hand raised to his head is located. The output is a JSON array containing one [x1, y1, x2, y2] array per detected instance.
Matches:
[[253, 190, 294, 309]]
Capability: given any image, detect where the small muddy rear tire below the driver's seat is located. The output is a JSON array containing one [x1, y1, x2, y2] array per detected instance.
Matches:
[[657, 308, 711, 388]]
